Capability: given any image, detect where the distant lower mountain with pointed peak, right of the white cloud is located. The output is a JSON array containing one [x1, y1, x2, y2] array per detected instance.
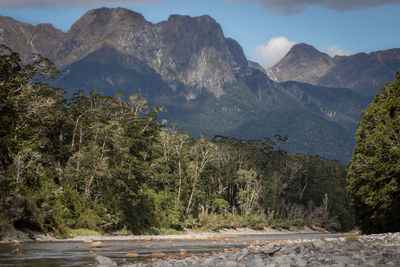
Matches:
[[267, 44, 400, 99]]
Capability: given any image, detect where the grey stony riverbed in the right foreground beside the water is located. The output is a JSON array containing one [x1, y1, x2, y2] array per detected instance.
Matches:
[[95, 233, 400, 267]]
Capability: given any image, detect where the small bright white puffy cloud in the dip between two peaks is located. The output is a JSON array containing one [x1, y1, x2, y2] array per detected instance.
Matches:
[[256, 36, 296, 68]]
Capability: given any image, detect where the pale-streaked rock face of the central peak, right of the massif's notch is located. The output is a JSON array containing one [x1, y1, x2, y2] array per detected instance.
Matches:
[[123, 12, 241, 99]]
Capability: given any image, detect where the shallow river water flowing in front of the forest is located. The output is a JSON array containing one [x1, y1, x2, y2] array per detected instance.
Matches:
[[0, 234, 341, 267]]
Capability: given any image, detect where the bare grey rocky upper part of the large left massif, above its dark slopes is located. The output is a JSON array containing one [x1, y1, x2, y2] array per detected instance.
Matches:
[[0, 8, 247, 99]]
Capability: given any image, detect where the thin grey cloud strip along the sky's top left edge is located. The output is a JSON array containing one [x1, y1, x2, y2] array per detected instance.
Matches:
[[0, 0, 157, 9]]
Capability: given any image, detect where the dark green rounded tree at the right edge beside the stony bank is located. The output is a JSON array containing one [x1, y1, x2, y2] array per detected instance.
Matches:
[[347, 73, 400, 233]]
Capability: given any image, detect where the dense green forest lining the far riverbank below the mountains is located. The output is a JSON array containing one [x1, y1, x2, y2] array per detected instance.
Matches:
[[0, 46, 354, 239]]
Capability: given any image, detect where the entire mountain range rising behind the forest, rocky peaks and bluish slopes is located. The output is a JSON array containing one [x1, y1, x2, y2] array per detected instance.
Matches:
[[0, 8, 400, 162]]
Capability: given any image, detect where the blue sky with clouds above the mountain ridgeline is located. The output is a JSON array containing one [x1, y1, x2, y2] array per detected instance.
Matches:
[[0, 0, 400, 66]]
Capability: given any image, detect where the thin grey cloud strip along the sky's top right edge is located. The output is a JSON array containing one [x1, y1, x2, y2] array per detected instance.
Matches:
[[243, 0, 400, 15]]
